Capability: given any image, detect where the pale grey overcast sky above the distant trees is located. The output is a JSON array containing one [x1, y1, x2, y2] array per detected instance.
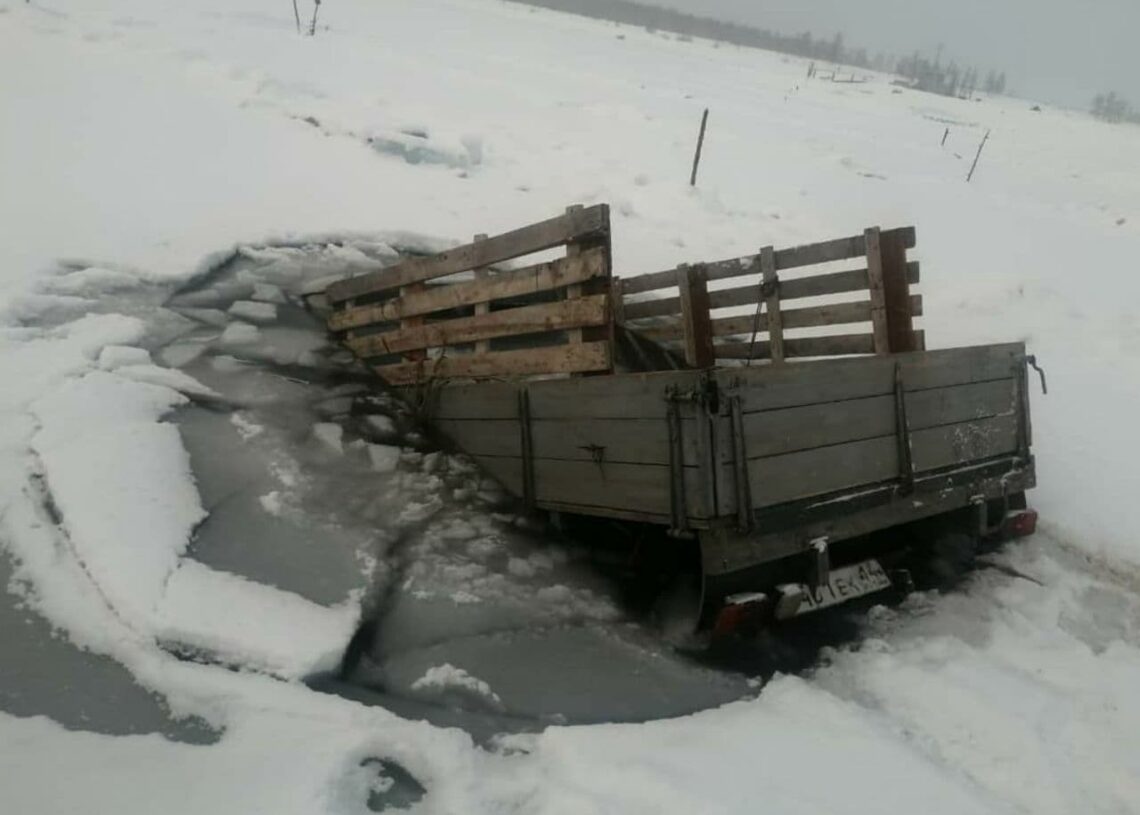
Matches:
[[643, 0, 1140, 109]]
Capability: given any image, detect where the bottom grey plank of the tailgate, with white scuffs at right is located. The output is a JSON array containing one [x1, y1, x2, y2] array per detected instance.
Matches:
[[748, 416, 1017, 507]]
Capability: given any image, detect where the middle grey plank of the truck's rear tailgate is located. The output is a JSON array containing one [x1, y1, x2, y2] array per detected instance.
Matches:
[[742, 378, 1015, 458]]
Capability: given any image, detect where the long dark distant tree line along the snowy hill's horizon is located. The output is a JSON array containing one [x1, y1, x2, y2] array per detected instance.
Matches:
[[514, 0, 1005, 98]]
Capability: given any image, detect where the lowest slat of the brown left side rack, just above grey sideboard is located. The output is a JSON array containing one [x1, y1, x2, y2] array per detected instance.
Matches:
[[375, 342, 612, 385]]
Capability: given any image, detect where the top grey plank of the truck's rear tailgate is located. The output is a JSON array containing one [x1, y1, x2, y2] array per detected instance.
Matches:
[[715, 343, 1025, 413]]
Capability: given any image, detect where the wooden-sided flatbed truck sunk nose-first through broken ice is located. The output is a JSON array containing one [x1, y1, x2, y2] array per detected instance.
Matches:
[[316, 204, 1044, 634]]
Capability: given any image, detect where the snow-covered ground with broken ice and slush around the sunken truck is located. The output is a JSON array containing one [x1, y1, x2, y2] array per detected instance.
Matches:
[[0, 0, 1140, 815]]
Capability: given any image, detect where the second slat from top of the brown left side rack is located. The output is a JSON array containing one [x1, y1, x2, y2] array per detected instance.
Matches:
[[328, 248, 606, 332]]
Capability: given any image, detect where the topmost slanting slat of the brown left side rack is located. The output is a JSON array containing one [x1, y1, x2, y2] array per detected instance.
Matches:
[[326, 204, 610, 303]]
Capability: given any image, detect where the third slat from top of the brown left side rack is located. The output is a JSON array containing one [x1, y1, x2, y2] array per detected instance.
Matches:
[[345, 294, 609, 358]]
